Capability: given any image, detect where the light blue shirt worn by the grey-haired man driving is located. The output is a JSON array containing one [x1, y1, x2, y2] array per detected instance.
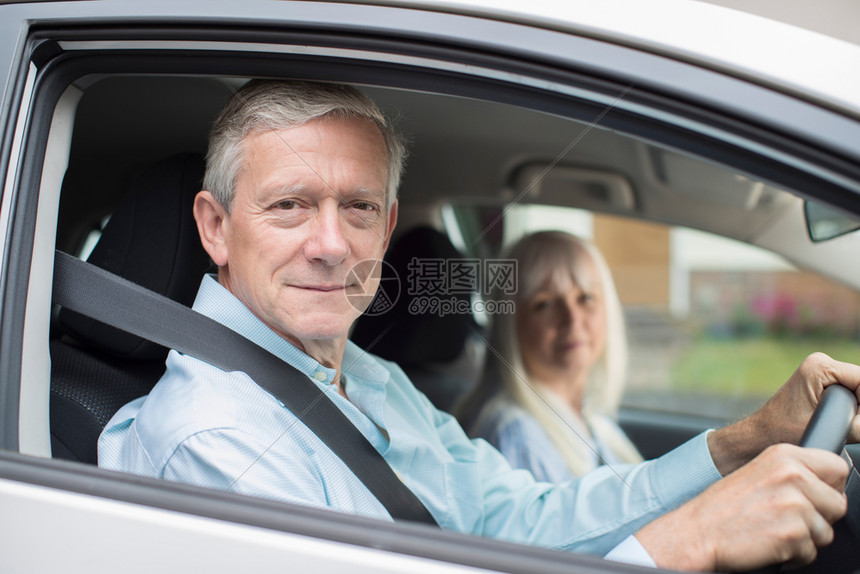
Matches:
[[99, 276, 719, 562]]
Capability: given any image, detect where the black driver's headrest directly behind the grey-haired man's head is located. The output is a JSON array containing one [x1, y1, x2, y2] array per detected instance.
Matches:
[[59, 154, 209, 359]]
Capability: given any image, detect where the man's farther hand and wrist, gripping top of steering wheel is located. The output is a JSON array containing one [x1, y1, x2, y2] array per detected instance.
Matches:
[[708, 353, 860, 476]]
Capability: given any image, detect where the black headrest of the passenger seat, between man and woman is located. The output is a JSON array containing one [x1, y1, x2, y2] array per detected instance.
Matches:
[[351, 227, 475, 367]]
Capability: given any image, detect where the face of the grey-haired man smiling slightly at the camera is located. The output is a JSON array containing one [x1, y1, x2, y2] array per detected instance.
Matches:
[[204, 118, 397, 348]]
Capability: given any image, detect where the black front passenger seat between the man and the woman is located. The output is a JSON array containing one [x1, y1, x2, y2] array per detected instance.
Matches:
[[350, 226, 482, 412]]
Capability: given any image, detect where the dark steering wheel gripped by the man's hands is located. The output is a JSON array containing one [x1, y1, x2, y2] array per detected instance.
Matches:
[[795, 385, 860, 574]]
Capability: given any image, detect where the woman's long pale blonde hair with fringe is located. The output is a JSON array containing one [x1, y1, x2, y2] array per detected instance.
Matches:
[[460, 231, 641, 475]]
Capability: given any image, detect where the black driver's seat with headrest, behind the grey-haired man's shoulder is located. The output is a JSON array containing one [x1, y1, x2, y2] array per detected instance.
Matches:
[[50, 154, 209, 464]]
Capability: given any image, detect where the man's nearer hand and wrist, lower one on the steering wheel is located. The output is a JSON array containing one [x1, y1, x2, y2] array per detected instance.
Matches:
[[636, 444, 849, 571]]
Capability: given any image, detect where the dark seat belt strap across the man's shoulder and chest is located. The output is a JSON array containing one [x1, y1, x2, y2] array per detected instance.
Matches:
[[53, 251, 436, 524]]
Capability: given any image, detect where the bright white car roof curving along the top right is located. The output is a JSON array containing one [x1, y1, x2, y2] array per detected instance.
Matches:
[[362, 0, 860, 117]]
